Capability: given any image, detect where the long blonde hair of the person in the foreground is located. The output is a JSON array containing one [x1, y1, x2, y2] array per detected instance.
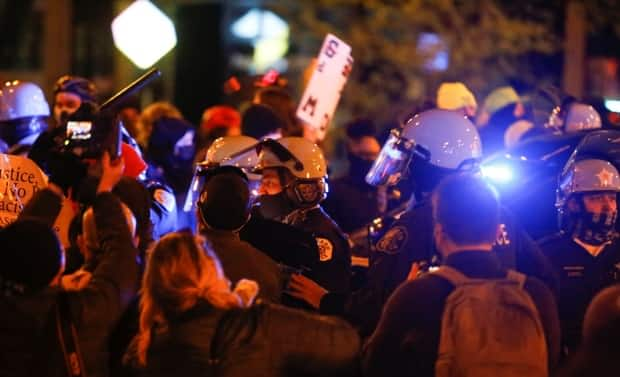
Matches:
[[135, 232, 245, 366]]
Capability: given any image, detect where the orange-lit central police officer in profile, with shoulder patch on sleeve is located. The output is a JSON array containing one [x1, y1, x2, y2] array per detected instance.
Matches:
[[255, 137, 351, 292]]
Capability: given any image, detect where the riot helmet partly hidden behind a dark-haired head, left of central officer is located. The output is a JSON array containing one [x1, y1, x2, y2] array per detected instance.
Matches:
[[183, 135, 260, 212]]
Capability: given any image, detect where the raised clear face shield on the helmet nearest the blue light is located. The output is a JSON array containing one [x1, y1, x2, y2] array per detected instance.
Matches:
[[366, 130, 414, 186]]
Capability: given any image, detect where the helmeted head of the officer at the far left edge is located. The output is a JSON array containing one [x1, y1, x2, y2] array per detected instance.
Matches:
[[0, 80, 50, 155]]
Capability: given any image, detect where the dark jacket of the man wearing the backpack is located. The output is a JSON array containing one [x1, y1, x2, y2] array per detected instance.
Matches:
[[362, 251, 560, 377]]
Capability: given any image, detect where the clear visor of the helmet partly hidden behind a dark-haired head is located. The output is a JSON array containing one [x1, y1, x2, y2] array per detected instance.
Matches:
[[183, 145, 261, 213]]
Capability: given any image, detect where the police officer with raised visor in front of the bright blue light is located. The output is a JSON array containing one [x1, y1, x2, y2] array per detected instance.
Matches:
[[293, 109, 555, 333]]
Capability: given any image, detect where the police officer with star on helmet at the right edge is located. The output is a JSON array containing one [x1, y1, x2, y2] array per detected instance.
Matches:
[[540, 159, 620, 352]]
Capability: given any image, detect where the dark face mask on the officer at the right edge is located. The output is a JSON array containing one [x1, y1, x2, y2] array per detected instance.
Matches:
[[572, 212, 618, 245]]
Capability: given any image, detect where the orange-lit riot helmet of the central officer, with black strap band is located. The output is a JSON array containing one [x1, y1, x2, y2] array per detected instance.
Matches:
[[255, 137, 328, 208]]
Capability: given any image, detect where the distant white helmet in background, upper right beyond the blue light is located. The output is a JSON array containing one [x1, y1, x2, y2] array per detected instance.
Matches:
[[545, 102, 602, 134]]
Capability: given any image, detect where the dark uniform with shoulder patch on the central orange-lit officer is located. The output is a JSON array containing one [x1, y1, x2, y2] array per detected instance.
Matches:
[[285, 205, 351, 292]]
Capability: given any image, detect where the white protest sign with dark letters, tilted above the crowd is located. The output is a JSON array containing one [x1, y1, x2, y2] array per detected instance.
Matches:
[[297, 34, 353, 140]]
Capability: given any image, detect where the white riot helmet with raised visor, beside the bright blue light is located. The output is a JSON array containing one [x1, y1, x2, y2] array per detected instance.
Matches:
[[366, 109, 482, 186]]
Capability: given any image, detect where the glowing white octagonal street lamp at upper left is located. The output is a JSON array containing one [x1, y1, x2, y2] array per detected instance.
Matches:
[[112, 0, 177, 69]]
